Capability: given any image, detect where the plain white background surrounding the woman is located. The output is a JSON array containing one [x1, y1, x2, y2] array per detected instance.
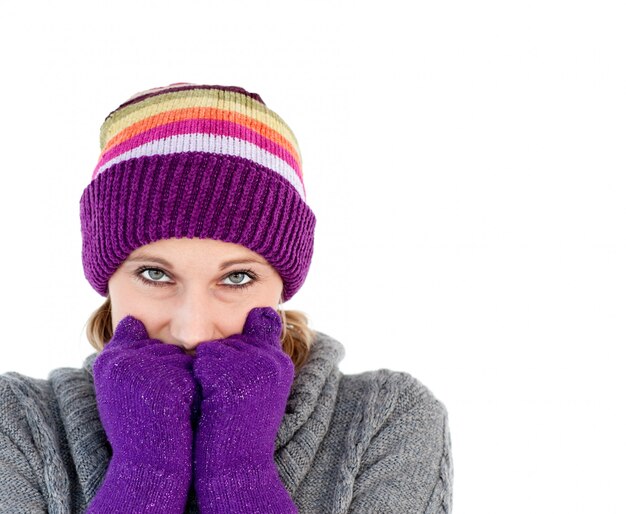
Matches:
[[0, 0, 626, 514]]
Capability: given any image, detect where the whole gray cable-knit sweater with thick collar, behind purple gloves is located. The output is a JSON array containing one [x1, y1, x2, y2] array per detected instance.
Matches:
[[0, 332, 452, 514]]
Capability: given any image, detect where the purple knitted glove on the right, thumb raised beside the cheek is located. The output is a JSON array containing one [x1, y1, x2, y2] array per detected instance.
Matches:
[[193, 307, 298, 514]]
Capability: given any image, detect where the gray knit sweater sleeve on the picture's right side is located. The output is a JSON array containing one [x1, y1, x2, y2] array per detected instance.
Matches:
[[349, 373, 453, 514]]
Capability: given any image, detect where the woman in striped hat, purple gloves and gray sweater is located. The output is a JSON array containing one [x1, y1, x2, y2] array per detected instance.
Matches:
[[0, 83, 452, 514]]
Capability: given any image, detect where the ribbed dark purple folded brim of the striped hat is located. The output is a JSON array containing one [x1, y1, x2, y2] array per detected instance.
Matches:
[[80, 152, 316, 301]]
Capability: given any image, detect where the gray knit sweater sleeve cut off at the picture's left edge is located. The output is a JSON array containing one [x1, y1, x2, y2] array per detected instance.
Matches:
[[0, 376, 48, 514]]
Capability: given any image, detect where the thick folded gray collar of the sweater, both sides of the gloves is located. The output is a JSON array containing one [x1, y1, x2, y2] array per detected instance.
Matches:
[[69, 332, 345, 500]]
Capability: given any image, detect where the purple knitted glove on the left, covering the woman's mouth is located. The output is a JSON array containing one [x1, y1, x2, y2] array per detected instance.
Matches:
[[87, 316, 195, 514]]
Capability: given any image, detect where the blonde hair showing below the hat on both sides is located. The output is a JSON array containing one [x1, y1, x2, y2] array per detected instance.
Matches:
[[85, 297, 315, 372]]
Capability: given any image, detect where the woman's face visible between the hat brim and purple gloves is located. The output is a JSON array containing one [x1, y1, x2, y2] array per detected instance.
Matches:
[[109, 238, 283, 354]]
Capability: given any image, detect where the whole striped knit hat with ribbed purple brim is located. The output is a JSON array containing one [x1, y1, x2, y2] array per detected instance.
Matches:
[[80, 83, 315, 301]]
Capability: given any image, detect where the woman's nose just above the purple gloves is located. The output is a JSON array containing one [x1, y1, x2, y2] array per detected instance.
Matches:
[[170, 290, 221, 355]]
